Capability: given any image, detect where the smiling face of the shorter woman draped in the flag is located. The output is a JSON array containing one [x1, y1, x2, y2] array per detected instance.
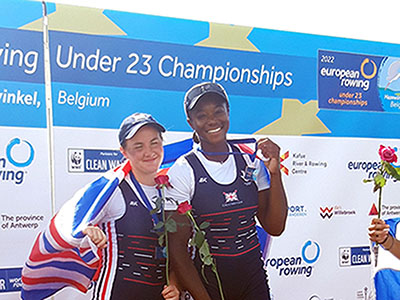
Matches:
[[121, 125, 164, 185]]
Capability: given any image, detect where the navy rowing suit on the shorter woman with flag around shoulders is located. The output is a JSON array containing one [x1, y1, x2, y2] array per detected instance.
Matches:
[[110, 181, 165, 300]]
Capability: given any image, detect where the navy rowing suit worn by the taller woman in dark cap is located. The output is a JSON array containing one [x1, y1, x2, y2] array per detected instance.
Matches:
[[185, 146, 270, 300]]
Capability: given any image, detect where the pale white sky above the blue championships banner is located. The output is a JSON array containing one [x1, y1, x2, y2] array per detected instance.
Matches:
[[35, 0, 400, 45]]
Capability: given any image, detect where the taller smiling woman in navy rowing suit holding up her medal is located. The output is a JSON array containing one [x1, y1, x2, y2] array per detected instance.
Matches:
[[166, 82, 287, 300]]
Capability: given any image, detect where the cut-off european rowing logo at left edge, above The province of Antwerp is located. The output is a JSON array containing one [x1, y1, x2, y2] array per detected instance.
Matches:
[[0, 138, 35, 185]]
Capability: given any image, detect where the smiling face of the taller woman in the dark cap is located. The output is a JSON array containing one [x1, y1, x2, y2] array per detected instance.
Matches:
[[188, 93, 229, 151]]
